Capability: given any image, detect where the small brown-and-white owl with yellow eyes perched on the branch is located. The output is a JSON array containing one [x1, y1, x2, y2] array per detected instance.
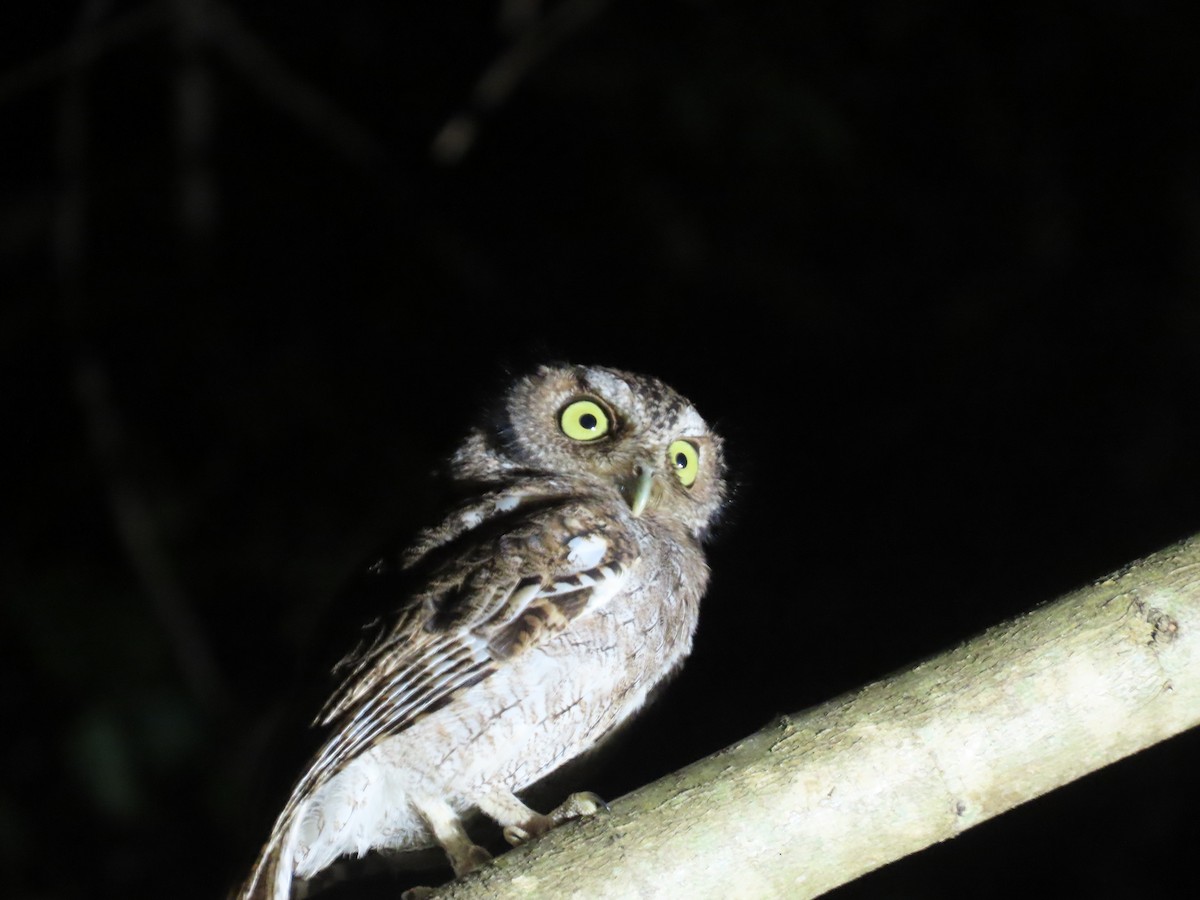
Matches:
[[238, 366, 726, 900]]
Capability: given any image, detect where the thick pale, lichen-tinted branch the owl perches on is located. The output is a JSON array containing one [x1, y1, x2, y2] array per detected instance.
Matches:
[[437, 535, 1200, 900]]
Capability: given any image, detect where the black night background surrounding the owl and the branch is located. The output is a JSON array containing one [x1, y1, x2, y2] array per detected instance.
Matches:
[[0, 0, 1200, 900]]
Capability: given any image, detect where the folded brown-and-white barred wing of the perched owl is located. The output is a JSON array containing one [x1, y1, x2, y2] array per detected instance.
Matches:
[[294, 500, 637, 796]]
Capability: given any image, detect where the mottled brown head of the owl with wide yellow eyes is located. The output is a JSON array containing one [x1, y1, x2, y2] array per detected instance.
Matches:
[[451, 366, 725, 539]]
